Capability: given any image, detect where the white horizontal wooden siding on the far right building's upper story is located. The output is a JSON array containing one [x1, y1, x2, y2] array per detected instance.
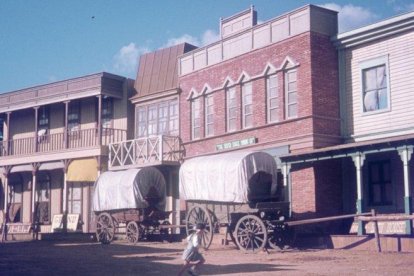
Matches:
[[345, 32, 414, 141]]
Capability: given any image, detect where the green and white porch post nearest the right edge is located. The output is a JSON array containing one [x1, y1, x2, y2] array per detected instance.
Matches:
[[398, 146, 413, 235]]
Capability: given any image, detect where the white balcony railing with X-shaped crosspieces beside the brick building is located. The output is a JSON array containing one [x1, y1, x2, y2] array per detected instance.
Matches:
[[108, 135, 183, 169]]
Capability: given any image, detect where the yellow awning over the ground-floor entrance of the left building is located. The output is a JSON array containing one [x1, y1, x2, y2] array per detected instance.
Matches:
[[66, 158, 98, 182]]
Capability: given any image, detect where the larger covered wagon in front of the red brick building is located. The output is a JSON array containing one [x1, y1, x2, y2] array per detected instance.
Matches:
[[180, 152, 289, 252]]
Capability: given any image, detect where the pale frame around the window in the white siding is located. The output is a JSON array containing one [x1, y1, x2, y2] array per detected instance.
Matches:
[[359, 55, 391, 116]]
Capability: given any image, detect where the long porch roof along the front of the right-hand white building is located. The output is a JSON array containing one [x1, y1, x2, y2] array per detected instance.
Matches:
[[279, 134, 414, 164]]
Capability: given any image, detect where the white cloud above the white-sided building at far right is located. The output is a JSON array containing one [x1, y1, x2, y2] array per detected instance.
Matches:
[[320, 3, 379, 33]]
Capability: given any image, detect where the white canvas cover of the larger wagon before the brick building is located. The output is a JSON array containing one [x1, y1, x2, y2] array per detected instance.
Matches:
[[180, 152, 277, 203]]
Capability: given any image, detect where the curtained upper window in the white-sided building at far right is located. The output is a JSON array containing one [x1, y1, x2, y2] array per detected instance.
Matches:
[[360, 57, 390, 113]]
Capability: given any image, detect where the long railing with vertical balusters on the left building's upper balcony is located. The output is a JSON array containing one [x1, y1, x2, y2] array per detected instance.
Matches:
[[0, 128, 126, 156]]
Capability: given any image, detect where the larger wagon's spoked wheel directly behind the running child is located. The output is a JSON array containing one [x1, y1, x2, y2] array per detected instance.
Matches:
[[185, 206, 214, 249]]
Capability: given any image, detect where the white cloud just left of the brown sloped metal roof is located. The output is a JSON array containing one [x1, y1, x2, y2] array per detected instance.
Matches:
[[113, 42, 150, 74]]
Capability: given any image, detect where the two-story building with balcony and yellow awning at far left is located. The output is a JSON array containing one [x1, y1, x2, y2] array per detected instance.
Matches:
[[0, 73, 133, 238]]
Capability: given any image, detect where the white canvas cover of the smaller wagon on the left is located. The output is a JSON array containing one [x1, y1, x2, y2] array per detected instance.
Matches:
[[93, 167, 166, 211]]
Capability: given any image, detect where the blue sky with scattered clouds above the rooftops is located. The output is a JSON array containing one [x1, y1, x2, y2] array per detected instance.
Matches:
[[0, 0, 414, 93]]
